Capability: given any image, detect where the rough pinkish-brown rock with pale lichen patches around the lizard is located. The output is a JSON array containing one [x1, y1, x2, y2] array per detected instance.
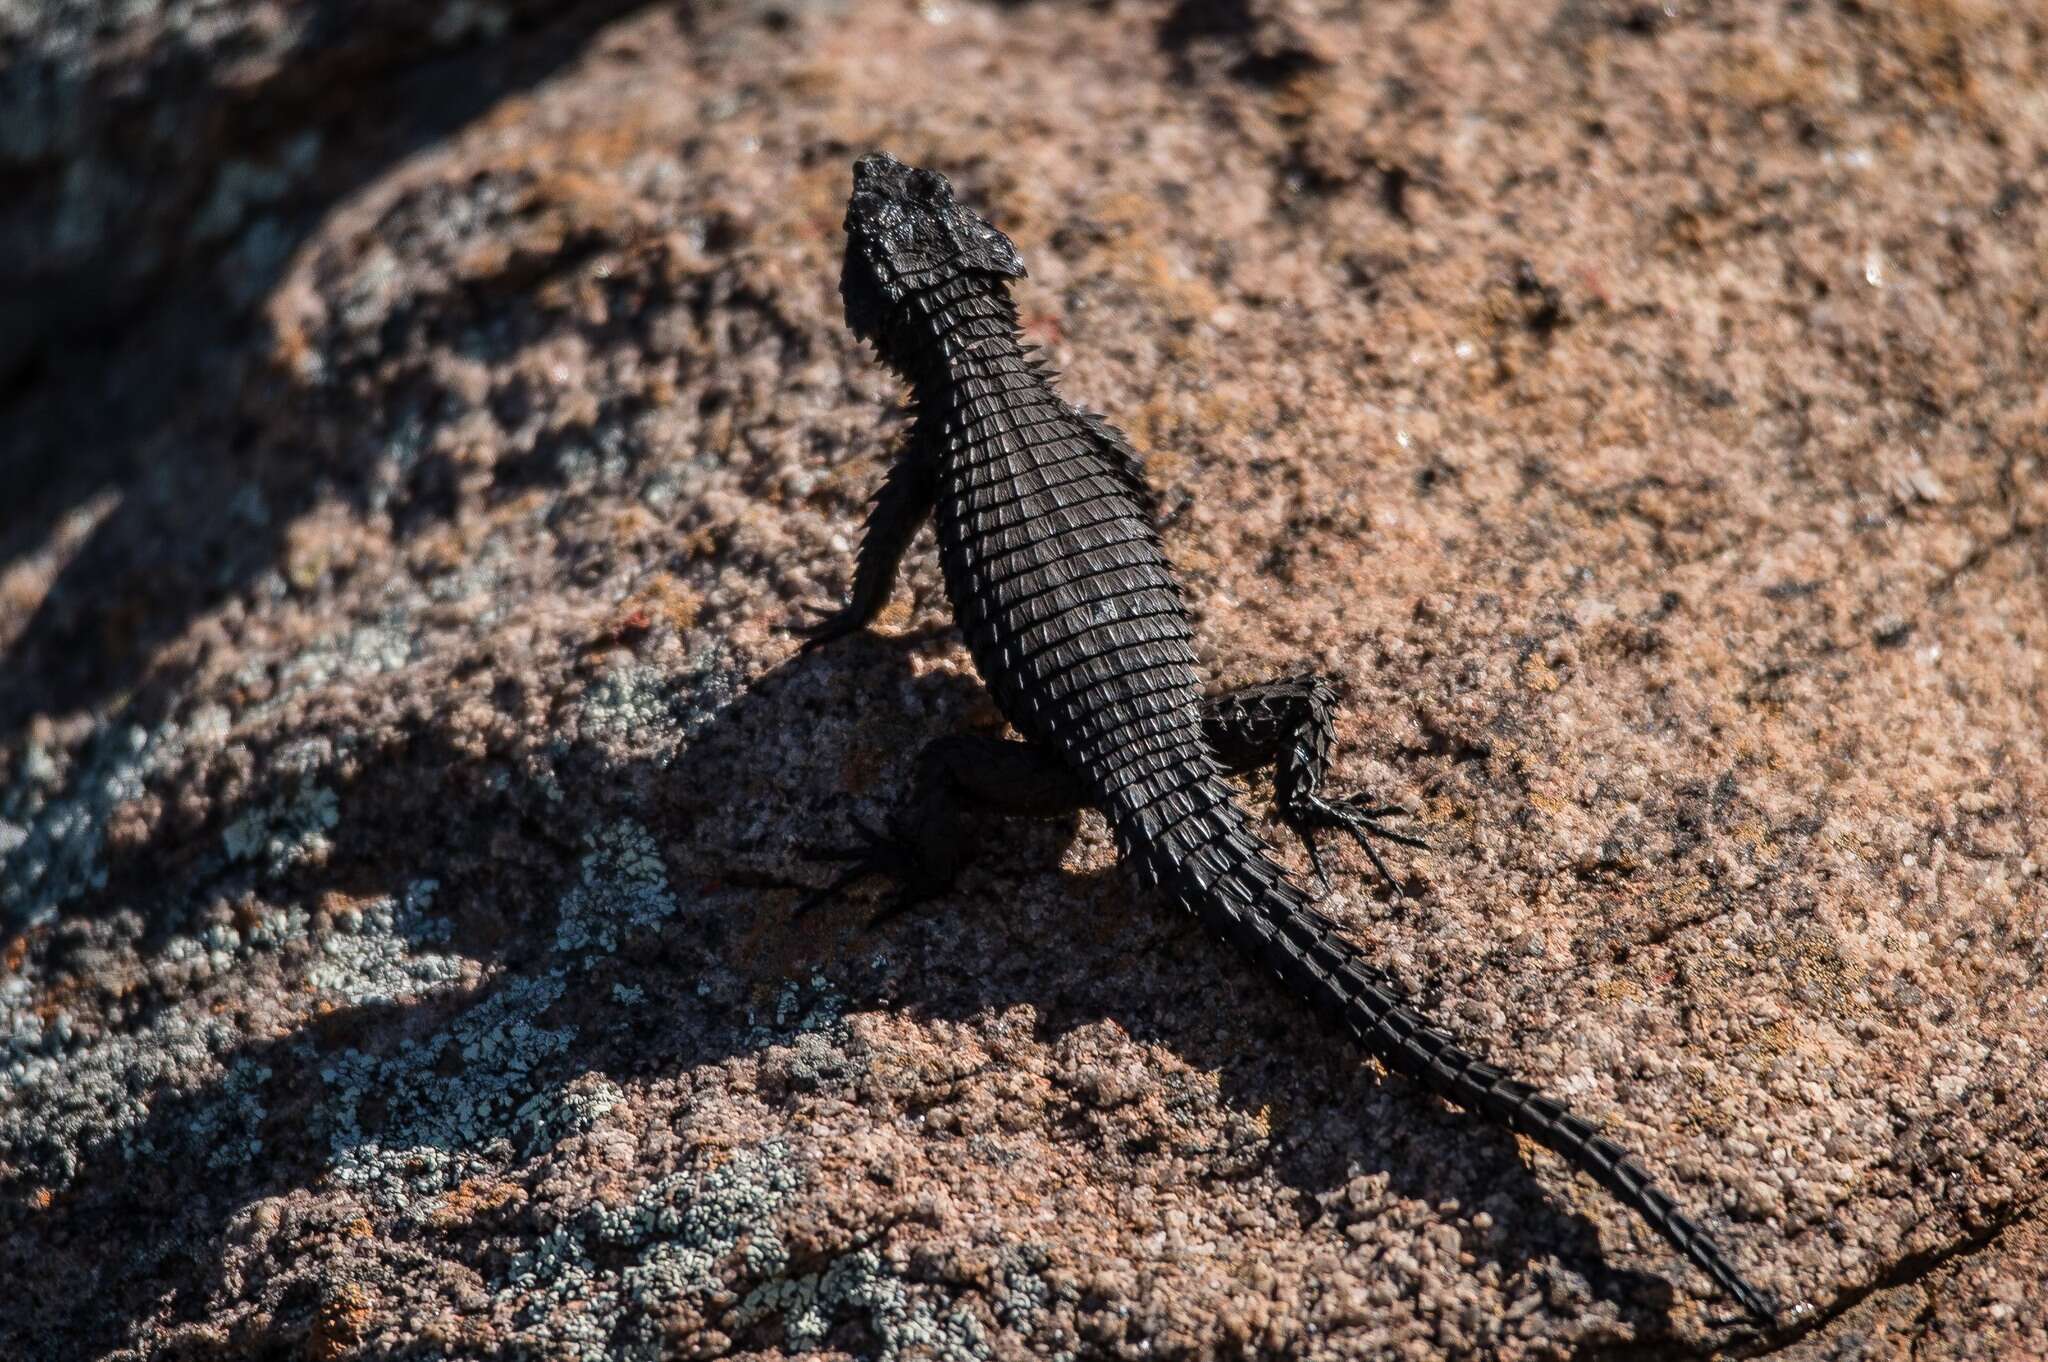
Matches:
[[0, 0, 2048, 1362]]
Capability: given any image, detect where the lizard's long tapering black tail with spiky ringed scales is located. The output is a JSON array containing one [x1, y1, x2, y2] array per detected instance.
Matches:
[[1145, 805, 1776, 1323]]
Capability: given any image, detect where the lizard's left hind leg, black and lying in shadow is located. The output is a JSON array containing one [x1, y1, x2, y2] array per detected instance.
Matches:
[[797, 735, 1090, 928]]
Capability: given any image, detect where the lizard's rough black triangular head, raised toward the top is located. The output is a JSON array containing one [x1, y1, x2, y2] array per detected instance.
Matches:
[[840, 152, 1024, 358]]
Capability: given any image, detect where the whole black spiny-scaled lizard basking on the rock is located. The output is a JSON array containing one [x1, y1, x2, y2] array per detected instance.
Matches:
[[790, 156, 1772, 1321]]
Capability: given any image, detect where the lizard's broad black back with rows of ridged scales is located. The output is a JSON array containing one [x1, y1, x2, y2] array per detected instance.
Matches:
[[920, 284, 1221, 850]]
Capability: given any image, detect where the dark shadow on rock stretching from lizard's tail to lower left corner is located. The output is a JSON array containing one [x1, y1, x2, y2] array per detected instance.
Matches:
[[0, 639, 1703, 1356]]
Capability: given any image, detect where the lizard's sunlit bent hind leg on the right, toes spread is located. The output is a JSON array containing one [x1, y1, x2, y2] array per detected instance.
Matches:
[[1202, 676, 1427, 893]]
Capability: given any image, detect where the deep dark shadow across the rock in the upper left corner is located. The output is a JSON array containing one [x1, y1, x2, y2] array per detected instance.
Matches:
[[0, 0, 645, 741]]
